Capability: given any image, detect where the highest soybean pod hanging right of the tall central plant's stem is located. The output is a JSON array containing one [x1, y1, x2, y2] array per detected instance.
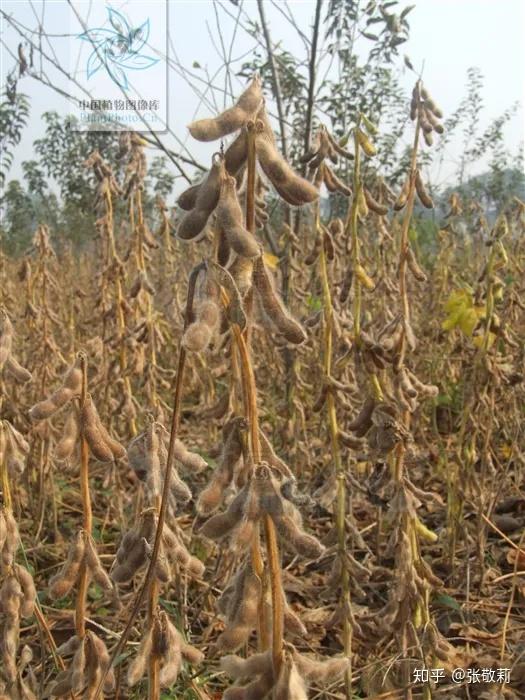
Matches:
[[255, 120, 319, 206]]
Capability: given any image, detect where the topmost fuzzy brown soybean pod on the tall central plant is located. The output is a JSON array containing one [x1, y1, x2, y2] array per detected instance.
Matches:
[[188, 75, 263, 141]]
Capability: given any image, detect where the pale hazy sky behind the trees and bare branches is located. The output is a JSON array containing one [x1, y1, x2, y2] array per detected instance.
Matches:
[[0, 0, 525, 197]]
